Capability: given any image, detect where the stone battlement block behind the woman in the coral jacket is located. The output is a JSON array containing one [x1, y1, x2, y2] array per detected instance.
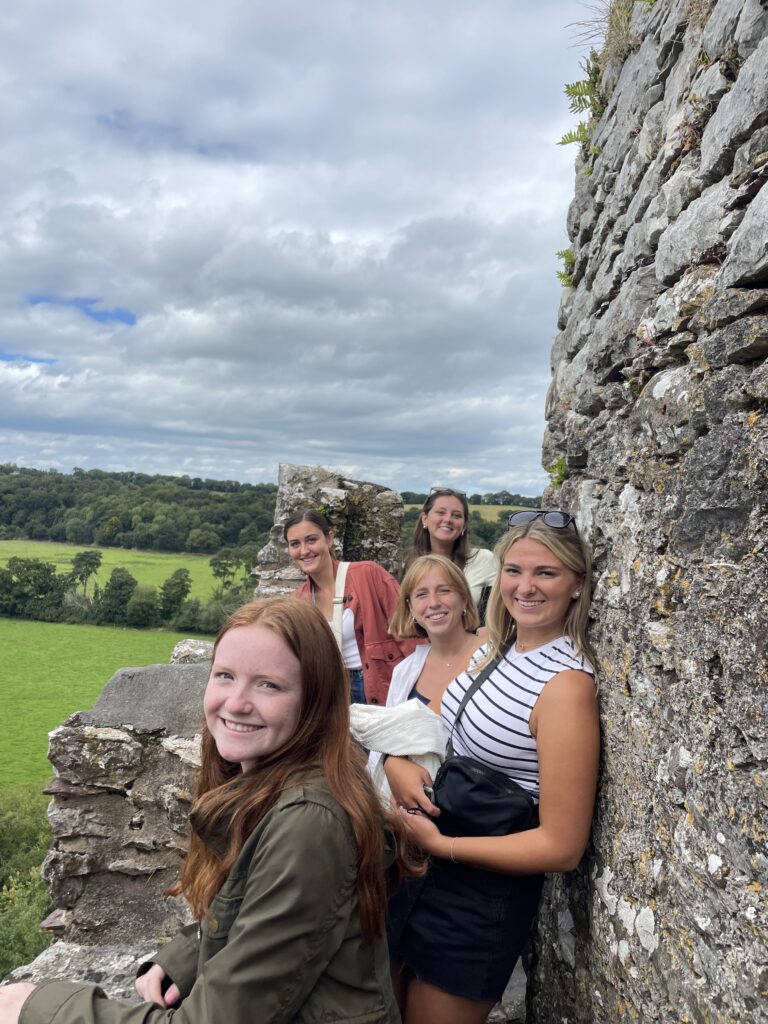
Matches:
[[253, 464, 402, 597]]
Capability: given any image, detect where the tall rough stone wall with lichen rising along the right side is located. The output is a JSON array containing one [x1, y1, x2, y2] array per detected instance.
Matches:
[[528, 0, 768, 1024]]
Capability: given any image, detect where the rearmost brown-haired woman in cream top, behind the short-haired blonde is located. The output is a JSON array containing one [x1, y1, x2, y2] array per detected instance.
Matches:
[[406, 487, 498, 623]]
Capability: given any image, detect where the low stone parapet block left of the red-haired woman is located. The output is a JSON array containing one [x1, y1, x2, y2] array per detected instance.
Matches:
[[43, 663, 208, 945]]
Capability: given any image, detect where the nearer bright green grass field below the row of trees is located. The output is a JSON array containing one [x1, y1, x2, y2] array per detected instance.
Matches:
[[0, 614, 214, 791]]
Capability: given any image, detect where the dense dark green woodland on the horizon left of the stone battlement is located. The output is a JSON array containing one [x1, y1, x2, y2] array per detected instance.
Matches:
[[0, 464, 278, 553]]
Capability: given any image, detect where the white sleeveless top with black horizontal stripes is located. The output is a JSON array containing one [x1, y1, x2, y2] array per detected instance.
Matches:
[[441, 637, 594, 798]]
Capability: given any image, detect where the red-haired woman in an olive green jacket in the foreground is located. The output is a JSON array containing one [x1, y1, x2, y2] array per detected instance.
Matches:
[[0, 598, 415, 1024]]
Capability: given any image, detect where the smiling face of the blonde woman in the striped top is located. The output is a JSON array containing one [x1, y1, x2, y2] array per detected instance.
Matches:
[[501, 537, 582, 643]]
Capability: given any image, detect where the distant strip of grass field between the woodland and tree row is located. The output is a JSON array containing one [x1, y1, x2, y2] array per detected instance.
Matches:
[[0, 541, 216, 600]]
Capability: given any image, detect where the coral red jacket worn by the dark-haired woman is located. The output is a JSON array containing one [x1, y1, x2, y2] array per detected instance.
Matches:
[[293, 559, 417, 705]]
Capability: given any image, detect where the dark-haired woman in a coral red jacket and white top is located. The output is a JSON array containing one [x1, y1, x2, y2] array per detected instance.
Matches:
[[283, 509, 416, 705]]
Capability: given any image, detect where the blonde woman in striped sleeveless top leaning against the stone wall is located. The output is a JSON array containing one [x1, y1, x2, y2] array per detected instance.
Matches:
[[385, 510, 600, 1024]]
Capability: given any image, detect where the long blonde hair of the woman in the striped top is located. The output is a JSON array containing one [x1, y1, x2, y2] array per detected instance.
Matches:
[[484, 518, 597, 672]]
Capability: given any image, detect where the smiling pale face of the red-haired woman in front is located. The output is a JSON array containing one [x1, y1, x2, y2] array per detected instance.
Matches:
[[203, 625, 302, 771]]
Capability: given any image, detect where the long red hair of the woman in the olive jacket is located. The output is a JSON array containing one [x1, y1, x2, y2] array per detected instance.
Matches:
[[170, 597, 418, 942]]
